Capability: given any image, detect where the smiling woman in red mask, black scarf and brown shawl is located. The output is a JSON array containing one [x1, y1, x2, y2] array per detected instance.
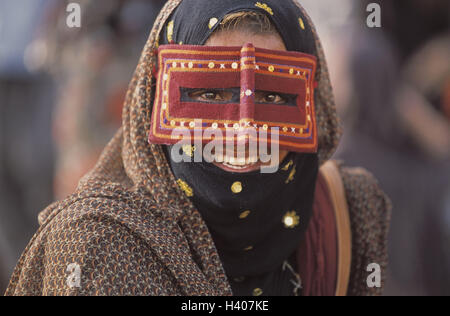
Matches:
[[7, 0, 389, 296]]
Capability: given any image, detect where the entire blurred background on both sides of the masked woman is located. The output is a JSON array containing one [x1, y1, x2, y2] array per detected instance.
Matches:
[[0, 0, 450, 295]]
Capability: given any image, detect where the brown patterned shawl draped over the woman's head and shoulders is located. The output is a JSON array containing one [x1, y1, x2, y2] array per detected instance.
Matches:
[[6, 0, 389, 295]]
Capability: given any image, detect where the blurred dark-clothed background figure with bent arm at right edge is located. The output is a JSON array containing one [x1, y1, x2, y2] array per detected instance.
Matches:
[[339, 0, 450, 295]]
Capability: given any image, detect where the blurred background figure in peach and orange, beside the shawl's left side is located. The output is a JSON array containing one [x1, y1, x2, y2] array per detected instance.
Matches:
[[41, 0, 165, 199]]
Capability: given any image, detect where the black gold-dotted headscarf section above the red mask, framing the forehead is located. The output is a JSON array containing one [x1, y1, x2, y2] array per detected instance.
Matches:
[[161, 0, 317, 55]]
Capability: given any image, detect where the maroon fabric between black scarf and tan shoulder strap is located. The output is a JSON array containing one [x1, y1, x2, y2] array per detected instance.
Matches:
[[297, 175, 338, 296]]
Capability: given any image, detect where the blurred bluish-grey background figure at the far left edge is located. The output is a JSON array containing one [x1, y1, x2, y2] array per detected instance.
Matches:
[[0, 0, 55, 292]]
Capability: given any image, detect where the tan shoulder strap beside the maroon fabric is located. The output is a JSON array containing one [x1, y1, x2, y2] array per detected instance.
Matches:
[[320, 160, 352, 296]]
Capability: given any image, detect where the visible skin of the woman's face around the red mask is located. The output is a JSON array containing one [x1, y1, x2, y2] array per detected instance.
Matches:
[[198, 30, 289, 173]]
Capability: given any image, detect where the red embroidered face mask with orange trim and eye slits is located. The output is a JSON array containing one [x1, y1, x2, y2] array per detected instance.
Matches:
[[149, 44, 317, 153]]
